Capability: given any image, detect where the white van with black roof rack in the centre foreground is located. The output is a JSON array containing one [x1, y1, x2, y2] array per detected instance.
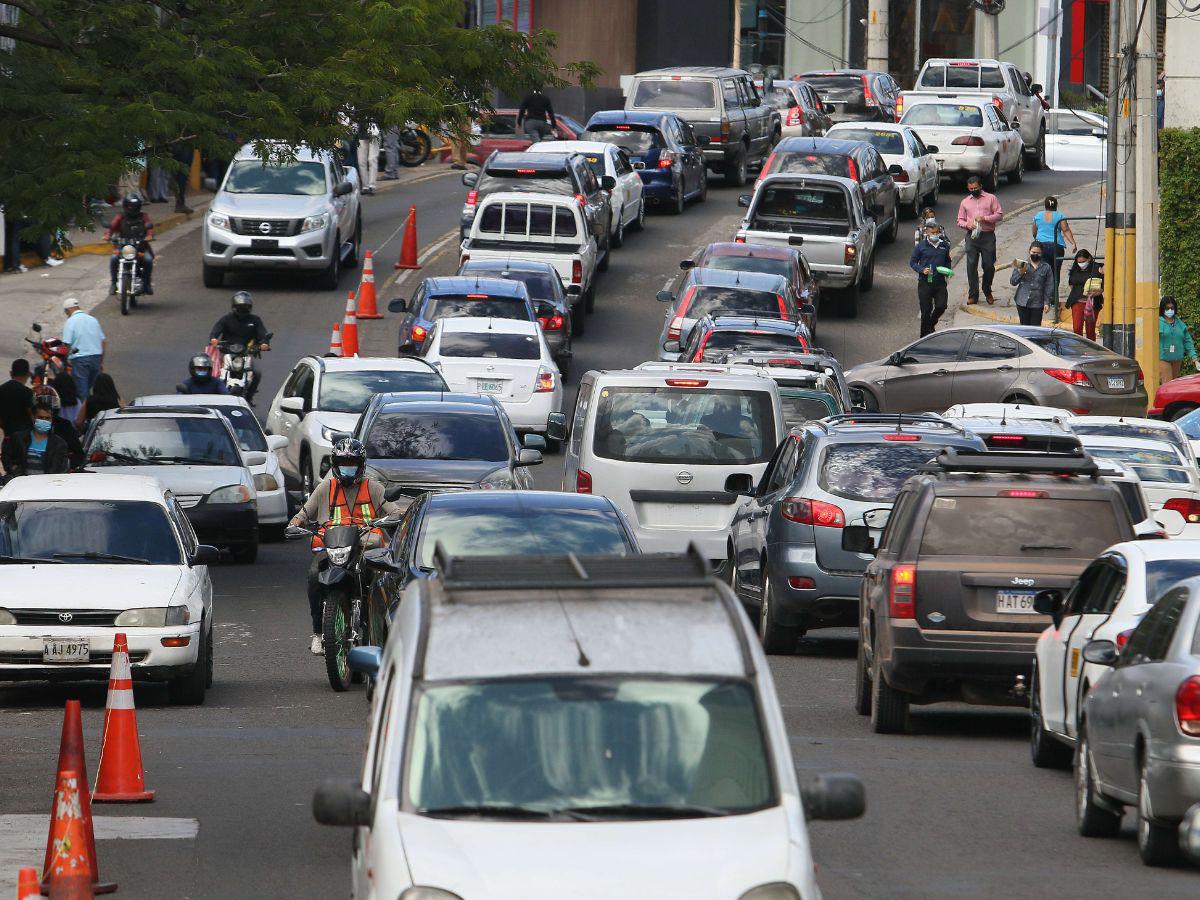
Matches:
[[313, 556, 864, 900]]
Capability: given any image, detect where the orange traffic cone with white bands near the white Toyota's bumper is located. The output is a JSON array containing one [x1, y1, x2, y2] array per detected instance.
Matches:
[[91, 631, 154, 803]]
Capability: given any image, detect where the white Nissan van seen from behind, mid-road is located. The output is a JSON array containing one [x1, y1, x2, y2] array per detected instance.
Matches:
[[563, 362, 786, 566]]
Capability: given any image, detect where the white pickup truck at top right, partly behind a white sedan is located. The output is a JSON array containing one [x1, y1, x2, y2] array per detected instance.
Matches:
[[896, 59, 1046, 169]]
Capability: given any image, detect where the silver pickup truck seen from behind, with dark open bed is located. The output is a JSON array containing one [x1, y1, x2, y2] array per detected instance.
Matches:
[[736, 175, 883, 319]]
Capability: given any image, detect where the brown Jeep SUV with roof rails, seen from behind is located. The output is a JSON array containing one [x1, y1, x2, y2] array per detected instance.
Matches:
[[842, 449, 1134, 733]]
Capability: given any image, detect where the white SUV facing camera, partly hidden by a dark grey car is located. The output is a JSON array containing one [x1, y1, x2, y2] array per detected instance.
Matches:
[[266, 356, 448, 497]]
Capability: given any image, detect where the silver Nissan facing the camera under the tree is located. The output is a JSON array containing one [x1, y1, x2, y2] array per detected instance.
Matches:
[[202, 144, 362, 288]]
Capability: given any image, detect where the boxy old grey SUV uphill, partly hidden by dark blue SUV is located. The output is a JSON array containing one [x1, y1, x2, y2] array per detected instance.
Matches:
[[625, 66, 780, 187]]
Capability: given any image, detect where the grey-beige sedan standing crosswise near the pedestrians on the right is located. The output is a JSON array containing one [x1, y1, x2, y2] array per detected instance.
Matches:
[[846, 325, 1146, 415]]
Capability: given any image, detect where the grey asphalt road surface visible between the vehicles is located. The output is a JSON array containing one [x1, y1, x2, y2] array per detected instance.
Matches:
[[0, 164, 1194, 900]]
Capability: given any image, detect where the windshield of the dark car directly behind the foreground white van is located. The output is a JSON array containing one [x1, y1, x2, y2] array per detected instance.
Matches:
[[416, 505, 629, 569]]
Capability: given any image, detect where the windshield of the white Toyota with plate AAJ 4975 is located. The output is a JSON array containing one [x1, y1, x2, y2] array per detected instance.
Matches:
[[0, 500, 182, 564]]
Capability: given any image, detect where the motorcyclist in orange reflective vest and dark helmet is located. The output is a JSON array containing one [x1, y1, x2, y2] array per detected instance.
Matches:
[[288, 438, 408, 656]]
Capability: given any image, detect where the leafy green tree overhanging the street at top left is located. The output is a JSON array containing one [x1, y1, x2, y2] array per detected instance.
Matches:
[[0, 0, 599, 229]]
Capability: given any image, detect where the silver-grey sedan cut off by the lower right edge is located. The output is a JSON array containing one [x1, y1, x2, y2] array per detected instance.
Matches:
[[1075, 577, 1200, 865]]
